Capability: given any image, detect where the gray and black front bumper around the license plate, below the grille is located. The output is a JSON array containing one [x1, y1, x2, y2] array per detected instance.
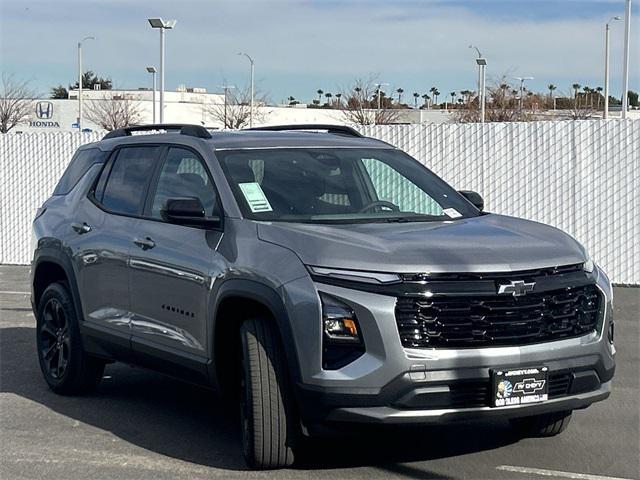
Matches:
[[284, 266, 615, 424]]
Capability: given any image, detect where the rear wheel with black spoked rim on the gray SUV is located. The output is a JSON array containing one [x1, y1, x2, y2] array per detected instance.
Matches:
[[36, 283, 105, 395]]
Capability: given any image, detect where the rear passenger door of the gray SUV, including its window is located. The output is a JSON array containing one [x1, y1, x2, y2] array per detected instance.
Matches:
[[72, 146, 161, 349]]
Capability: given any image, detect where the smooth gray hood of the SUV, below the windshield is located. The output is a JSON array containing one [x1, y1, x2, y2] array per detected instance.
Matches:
[[258, 214, 586, 273]]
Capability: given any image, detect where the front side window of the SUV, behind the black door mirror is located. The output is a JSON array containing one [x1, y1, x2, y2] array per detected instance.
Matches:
[[151, 147, 216, 218]]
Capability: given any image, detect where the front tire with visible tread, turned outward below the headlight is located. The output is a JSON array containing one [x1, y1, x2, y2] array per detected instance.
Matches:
[[240, 319, 297, 470]]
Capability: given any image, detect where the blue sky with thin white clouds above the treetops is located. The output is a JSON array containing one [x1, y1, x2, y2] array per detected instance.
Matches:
[[0, 0, 640, 102]]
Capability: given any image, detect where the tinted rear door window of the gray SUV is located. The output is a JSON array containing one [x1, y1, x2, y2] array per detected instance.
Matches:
[[96, 147, 160, 215]]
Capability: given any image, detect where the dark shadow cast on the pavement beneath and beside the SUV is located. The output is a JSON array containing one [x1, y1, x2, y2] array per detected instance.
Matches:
[[0, 327, 517, 472]]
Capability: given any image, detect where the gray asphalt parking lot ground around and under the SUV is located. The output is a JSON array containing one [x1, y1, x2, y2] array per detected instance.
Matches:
[[0, 266, 640, 480]]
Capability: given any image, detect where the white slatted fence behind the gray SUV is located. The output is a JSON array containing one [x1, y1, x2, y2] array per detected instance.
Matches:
[[0, 120, 640, 285]]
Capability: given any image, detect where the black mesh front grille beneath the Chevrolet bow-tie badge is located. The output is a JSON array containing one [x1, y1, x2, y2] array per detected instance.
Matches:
[[396, 285, 601, 348]]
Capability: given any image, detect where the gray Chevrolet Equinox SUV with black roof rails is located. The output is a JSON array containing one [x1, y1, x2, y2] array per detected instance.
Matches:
[[32, 125, 615, 468]]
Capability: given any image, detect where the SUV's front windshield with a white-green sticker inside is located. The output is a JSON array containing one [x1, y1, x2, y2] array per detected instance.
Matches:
[[216, 148, 479, 223]]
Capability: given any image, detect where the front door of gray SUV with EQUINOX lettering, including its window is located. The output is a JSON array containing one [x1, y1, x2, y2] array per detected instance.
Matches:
[[130, 146, 222, 378]]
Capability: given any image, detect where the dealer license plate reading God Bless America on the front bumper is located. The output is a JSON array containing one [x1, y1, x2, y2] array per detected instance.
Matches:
[[491, 367, 549, 407]]
